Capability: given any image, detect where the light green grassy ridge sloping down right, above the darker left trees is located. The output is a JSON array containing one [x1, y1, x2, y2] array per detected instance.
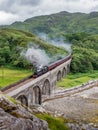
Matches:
[[0, 28, 66, 56]]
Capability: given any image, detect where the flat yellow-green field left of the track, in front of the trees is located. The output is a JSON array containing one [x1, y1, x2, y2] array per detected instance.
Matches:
[[0, 67, 32, 88]]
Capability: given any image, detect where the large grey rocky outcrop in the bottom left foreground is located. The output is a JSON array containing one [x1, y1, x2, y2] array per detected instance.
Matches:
[[0, 93, 48, 130]]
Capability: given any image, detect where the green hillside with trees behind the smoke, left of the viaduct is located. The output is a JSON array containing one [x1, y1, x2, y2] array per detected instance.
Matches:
[[0, 29, 67, 68]]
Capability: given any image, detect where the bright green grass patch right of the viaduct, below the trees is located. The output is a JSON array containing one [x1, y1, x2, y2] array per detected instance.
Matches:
[[57, 71, 98, 88]]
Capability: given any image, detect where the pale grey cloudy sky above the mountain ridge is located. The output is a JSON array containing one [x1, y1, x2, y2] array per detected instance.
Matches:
[[0, 0, 98, 25]]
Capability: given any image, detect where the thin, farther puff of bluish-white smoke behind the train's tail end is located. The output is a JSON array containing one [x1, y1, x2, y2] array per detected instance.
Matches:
[[38, 33, 72, 53]]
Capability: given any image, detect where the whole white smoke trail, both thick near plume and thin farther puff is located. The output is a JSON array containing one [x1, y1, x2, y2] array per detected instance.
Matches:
[[21, 33, 71, 66]]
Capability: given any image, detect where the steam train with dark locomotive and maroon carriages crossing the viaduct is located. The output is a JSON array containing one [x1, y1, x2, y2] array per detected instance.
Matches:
[[33, 54, 71, 78]]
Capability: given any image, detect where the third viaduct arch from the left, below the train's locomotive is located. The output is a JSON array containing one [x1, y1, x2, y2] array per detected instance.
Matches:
[[42, 79, 50, 95]]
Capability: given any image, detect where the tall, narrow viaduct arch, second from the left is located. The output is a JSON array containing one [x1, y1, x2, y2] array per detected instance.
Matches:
[[33, 86, 41, 104]]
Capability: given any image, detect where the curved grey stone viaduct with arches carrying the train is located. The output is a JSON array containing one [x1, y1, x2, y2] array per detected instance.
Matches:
[[6, 56, 71, 107]]
